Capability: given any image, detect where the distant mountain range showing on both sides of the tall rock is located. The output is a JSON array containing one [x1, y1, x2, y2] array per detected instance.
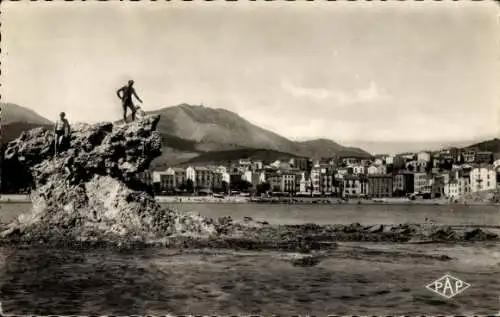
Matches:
[[1, 103, 370, 169]]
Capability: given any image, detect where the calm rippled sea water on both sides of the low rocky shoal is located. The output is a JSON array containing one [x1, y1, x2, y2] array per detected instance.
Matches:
[[0, 204, 500, 315]]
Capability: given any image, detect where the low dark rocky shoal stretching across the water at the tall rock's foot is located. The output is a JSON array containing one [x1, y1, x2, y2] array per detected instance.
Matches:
[[0, 211, 499, 253]]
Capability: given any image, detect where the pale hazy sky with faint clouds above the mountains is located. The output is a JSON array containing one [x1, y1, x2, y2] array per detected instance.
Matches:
[[1, 1, 500, 150]]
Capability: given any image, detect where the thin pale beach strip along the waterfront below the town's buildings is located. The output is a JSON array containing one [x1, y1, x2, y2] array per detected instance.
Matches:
[[0, 195, 500, 206]]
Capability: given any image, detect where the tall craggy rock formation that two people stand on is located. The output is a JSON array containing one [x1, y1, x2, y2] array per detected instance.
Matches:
[[2, 116, 215, 244]]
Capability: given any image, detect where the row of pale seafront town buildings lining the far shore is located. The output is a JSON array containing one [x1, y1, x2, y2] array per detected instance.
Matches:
[[142, 149, 500, 198]]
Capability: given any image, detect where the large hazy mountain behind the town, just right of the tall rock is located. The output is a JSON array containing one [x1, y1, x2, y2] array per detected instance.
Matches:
[[149, 104, 370, 164]]
